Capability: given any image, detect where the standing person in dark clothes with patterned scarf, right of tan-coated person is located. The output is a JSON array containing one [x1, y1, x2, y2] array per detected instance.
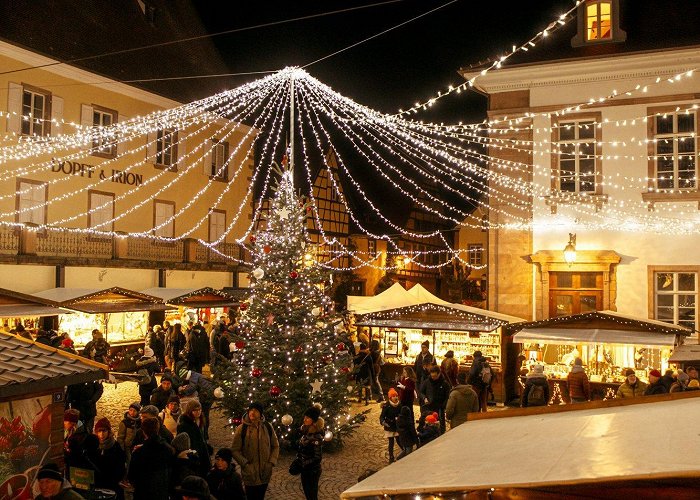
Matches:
[[297, 406, 325, 500]]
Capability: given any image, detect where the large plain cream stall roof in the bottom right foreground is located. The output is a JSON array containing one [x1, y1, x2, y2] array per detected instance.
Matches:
[[341, 397, 700, 499]]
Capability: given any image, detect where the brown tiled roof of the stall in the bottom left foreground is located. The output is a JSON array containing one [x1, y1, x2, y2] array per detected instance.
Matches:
[[0, 333, 107, 398]]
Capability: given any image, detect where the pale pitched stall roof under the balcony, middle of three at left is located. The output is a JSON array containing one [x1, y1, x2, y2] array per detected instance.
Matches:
[[32, 287, 166, 314]]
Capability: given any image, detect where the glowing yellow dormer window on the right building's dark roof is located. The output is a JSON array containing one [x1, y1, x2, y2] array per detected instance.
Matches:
[[571, 0, 627, 47]]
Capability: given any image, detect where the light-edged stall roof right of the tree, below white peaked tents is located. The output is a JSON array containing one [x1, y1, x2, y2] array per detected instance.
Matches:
[[355, 303, 506, 332]]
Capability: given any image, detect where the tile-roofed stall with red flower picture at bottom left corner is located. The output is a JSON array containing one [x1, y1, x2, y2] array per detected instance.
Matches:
[[0, 333, 107, 499]]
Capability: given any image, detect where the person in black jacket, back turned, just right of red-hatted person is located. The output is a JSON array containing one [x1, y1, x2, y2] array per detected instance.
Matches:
[[127, 418, 174, 500]]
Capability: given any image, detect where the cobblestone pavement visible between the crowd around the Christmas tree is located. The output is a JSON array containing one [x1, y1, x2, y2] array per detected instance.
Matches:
[[97, 382, 399, 500]]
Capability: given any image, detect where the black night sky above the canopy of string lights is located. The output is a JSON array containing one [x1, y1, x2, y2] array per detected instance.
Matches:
[[196, 0, 573, 122]]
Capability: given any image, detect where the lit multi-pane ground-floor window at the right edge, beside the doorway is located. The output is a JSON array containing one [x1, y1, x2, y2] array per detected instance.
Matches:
[[654, 271, 698, 330]]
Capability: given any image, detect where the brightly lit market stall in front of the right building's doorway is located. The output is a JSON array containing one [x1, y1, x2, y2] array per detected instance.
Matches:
[[508, 311, 691, 403]]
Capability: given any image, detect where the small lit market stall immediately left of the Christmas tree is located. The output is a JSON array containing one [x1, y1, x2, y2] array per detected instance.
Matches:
[[141, 287, 240, 325]]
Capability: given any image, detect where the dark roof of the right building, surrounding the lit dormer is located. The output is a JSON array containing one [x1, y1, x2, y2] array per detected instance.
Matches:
[[459, 0, 700, 75]]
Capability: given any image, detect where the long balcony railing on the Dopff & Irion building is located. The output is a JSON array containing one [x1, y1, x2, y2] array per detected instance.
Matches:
[[0, 224, 241, 265]]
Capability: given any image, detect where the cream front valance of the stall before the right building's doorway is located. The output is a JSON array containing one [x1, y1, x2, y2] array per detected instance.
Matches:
[[513, 328, 676, 347]]
